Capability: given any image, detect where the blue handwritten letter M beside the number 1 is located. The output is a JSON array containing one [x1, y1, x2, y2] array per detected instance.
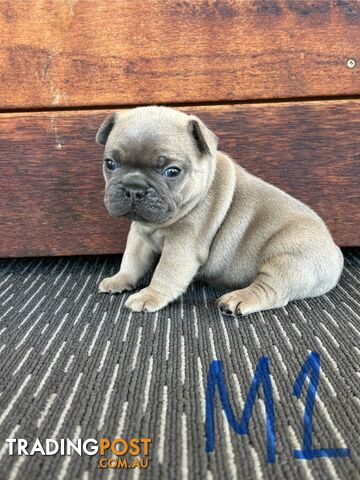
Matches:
[[205, 357, 276, 463]]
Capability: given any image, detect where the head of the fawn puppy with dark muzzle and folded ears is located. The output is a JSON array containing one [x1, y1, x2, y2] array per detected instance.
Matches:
[[96, 107, 217, 224]]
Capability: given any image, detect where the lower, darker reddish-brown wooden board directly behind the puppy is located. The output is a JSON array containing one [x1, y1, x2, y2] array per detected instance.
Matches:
[[0, 100, 360, 257]]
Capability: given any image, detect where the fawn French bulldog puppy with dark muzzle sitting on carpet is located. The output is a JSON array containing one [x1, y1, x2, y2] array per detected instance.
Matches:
[[96, 106, 343, 315]]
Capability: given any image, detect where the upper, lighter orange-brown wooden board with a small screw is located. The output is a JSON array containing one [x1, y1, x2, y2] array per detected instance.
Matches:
[[0, 0, 360, 109]]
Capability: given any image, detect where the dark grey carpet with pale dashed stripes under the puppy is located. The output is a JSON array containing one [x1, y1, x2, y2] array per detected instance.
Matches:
[[0, 250, 360, 480]]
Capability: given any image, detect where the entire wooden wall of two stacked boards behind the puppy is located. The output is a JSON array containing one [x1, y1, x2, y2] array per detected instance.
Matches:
[[0, 0, 360, 257]]
